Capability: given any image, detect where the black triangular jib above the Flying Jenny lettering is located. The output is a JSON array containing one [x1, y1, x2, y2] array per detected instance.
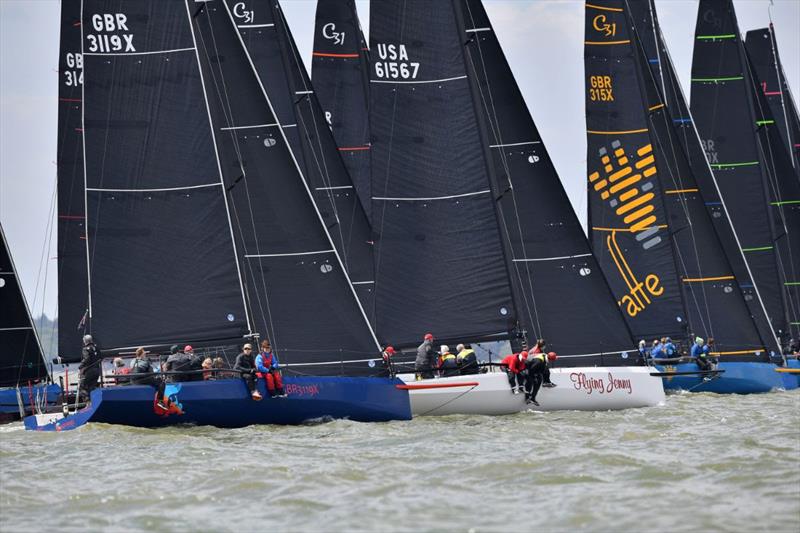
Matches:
[[462, 0, 636, 366]]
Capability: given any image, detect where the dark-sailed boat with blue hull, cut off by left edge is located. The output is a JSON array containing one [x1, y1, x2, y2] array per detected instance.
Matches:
[[0, 226, 61, 422]]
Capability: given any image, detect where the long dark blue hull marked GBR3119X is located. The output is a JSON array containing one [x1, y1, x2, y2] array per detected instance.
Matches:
[[25, 377, 411, 431]]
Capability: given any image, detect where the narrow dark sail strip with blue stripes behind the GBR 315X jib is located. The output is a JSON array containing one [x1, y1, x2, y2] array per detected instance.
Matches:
[[626, 0, 779, 349]]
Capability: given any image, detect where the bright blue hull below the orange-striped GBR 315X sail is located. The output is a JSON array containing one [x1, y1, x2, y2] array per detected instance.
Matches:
[[657, 362, 797, 394]]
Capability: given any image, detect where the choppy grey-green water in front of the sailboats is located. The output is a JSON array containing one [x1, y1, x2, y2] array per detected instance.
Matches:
[[0, 390, 800, 532]]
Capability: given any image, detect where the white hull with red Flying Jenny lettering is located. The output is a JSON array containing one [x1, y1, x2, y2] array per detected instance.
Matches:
[[399, 367, 664, 416]]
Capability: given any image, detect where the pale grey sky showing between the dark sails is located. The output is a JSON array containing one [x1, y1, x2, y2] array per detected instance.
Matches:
[[0, 0, 800, 316]]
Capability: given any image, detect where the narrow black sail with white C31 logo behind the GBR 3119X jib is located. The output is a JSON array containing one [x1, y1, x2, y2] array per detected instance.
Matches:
[[231, 0, 374, 319]]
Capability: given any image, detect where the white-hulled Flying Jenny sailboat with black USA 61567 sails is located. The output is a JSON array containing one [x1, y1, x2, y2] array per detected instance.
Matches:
[[358, 0, 664, 415]]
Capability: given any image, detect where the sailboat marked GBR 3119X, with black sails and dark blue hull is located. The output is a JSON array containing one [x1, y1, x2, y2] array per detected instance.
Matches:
[[25, 0, 411, 431]]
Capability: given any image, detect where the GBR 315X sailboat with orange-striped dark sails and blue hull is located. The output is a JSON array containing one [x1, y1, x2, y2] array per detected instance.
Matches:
[[584, 0, 783, 393]]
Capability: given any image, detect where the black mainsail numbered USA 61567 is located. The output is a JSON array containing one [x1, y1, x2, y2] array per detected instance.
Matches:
[[370, 0, 520, 346]]
